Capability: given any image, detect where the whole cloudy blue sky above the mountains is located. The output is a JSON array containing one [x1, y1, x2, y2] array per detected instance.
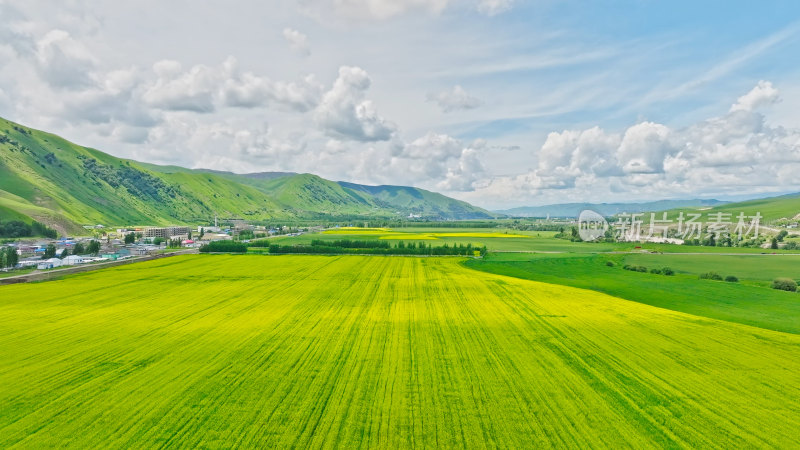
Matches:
[[0, 0, 800, 208]]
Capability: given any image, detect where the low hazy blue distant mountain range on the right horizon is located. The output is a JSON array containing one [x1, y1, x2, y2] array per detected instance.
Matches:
[[495, 199, 729, 218]]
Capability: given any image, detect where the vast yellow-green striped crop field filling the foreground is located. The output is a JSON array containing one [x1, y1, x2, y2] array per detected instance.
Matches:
[[0, 255, 800, 448]]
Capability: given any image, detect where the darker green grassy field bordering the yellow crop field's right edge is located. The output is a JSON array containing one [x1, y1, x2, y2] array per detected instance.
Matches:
[[465, 254, 800, 334]]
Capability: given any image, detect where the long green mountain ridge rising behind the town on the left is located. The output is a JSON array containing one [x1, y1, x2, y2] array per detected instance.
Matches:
[[0, 119, 493, 231]]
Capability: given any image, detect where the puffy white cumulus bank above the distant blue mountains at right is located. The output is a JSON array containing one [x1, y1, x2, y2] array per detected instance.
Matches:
[[468, 81, 800, 206]]
